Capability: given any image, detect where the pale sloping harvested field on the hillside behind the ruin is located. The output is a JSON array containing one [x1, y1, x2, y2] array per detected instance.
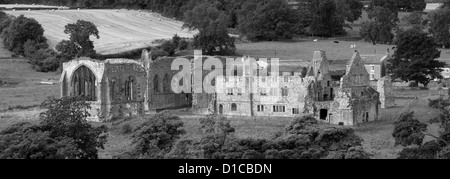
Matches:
[[6, 10, 196, 54]]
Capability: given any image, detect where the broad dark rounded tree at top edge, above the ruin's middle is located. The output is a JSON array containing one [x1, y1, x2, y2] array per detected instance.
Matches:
[[238, 0, 297, 41]]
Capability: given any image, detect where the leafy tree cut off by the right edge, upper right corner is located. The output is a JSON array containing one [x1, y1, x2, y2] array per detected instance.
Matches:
[[428, 8, 450, 48]]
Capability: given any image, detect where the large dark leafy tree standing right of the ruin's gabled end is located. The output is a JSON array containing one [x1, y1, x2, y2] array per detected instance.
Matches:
[[387, 29, 445, 86]]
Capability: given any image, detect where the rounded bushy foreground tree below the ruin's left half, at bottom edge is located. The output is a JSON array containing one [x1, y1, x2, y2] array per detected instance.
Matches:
[[130, 114, 185, 159]]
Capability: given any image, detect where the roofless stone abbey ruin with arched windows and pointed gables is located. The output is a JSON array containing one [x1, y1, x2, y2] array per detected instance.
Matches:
[[61, 50, 394, 125]]
